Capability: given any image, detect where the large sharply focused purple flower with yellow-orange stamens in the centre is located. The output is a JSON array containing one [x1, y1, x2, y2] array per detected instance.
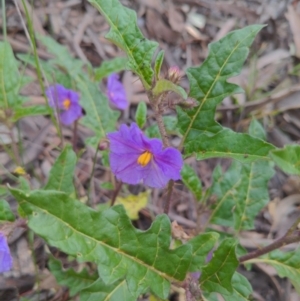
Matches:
[[107, 123, 183, 188]]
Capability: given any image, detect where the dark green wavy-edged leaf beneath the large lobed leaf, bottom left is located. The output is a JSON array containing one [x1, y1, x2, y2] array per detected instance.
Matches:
[[48, 257, 98, 296]]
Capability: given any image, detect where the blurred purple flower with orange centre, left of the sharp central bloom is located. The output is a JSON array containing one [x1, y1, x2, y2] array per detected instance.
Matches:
[[46, 84, 82, 125]]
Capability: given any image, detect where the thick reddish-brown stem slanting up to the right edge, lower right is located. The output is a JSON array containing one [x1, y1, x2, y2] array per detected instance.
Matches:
[[239, 231, 300, 263]]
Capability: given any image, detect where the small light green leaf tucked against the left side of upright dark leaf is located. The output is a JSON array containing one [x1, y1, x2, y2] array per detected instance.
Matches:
[[188, 232, 219, 272]]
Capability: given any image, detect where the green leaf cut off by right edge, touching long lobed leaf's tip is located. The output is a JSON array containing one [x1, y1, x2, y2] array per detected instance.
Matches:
[[270, 145, 300, 175]]
